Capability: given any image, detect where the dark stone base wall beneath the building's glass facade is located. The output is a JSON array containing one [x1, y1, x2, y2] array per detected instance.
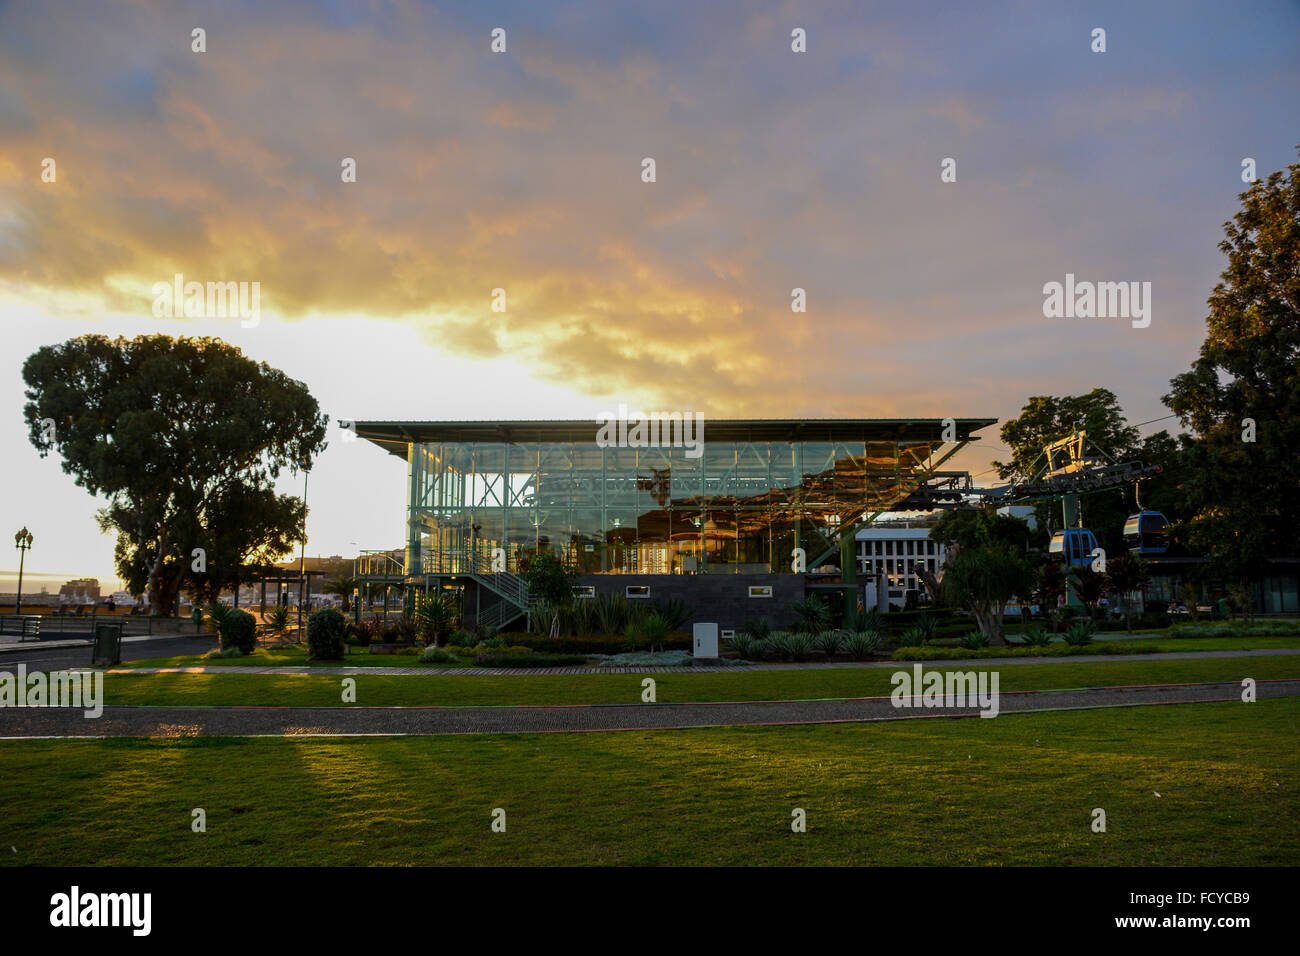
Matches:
[[575, 574, 803, 633]]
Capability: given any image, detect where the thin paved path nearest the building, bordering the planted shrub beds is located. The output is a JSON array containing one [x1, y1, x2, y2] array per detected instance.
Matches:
[[98, 648, 1300, 678]]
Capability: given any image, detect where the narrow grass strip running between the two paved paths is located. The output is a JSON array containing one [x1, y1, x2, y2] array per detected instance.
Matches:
[[104, 654, 1300, 706]]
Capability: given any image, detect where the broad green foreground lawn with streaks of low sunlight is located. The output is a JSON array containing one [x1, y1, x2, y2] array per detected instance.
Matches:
[[0, 697, 1300, 866]]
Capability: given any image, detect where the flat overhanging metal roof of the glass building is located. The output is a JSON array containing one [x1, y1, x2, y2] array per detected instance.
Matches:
[[352, 418, 997, 459]]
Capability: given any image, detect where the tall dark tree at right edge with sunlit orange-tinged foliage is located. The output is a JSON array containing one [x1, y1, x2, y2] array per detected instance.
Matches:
[[1165, 150, 1300, 581]]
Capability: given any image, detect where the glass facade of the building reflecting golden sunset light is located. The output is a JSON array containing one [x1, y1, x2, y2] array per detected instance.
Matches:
[[384, 421, 977, 575]]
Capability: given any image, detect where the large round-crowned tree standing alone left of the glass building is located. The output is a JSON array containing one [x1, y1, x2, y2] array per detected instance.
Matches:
[[22, 336, 328, 615]]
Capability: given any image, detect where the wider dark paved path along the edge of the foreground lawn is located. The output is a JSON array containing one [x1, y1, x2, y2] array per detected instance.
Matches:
[[0, 680, 1300, 739]]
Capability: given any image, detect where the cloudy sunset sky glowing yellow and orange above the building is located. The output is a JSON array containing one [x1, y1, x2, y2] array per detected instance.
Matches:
[[0, 0, 1300, 591]]
